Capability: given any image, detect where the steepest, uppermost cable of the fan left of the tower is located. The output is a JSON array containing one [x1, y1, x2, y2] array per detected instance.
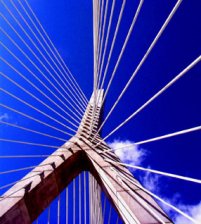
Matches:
[[24, 0, 88, 105]]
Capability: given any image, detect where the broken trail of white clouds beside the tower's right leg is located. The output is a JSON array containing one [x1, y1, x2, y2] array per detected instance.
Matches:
[[108, 140, 201, 224]]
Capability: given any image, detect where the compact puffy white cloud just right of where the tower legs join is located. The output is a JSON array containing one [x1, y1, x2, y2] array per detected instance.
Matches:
[[108, 140, 146, 165]]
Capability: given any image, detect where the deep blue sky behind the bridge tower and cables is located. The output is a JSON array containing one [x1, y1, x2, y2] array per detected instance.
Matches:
[[0, 0, 201, 223]]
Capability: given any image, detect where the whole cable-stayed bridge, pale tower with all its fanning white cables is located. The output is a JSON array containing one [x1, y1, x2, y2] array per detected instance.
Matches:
[[0, 0, 201, 223]]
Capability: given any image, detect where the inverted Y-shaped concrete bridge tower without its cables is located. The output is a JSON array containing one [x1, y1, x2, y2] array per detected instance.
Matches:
[[0, 90, 172, 224]]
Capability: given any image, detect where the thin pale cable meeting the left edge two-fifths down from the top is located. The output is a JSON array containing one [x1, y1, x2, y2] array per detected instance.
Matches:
[[0, 88, 76, 132]]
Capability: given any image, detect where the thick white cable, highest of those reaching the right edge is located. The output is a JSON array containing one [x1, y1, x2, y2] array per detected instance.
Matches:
[[103, 56, 201, 144]]
